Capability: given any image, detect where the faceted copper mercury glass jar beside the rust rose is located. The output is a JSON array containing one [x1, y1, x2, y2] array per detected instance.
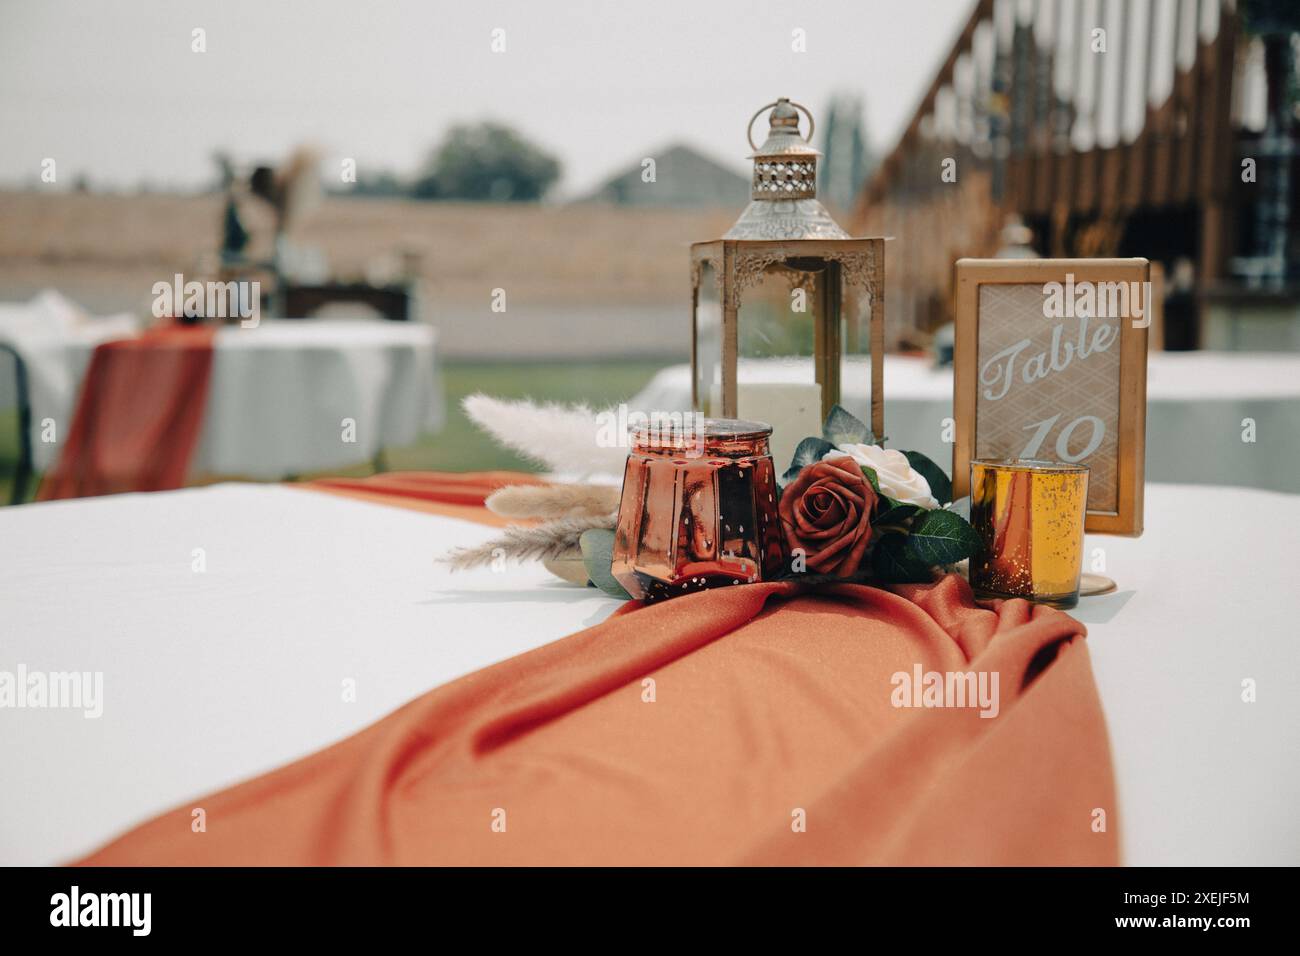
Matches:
[[612, 416, 785, 601]]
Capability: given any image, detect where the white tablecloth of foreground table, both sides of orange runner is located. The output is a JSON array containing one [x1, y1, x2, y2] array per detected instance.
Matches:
[[0, 485, 1300, 865]]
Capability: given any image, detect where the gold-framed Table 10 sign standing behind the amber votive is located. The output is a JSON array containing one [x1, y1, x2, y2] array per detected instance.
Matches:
[[953, 259, 1152, 535]]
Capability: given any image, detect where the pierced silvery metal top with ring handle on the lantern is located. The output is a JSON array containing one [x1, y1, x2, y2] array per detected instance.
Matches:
[[723, 96, 849, 239]]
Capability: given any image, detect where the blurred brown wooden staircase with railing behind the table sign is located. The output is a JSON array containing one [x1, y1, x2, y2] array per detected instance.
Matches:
[[853, 0, 1300, 351]]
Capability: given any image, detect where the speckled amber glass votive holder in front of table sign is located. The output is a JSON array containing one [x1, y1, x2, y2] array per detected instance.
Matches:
[[970, 458, 1088, 607]]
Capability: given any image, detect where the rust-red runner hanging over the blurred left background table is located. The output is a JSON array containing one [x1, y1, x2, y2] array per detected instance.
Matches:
[[36, 325, 216, 501]]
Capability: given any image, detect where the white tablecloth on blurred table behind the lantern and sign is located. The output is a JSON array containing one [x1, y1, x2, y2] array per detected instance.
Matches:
[[628, 352, 1300, 492]]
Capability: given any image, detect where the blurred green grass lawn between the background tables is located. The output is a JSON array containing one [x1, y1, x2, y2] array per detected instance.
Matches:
[[0, 359, 671, 505]]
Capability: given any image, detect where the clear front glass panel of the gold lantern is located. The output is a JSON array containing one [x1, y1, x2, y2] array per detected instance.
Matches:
[[736, 260, 836, 472]]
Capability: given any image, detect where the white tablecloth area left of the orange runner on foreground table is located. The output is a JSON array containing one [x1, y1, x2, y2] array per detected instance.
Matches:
[[0, 484, 619, 865]]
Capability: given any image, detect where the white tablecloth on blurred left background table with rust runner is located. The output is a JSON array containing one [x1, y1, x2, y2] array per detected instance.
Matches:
[[0, 297, 443, 479]]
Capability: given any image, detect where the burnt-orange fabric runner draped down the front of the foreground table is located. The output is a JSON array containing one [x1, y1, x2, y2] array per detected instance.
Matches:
[[83, 475, 1118, 865]]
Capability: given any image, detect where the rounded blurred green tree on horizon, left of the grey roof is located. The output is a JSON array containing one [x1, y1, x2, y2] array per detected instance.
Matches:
[[412, 122, 560, 202]]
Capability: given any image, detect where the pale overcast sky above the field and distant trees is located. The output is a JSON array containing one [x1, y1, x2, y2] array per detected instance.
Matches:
[[0, 0, 974, 194]]
